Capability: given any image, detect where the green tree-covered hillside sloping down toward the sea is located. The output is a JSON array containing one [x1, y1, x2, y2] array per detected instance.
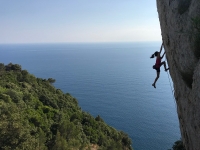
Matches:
[[0, 63, 132, 150]]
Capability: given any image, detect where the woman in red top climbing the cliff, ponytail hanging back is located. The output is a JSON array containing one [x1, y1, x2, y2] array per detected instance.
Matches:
[[150, 43, 169, 88]]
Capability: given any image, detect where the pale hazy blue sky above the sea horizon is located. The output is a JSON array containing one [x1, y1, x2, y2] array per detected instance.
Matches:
[[0, 0, 161, 43]]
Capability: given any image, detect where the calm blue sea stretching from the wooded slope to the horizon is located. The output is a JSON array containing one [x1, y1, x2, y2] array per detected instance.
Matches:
[[0, 43, 180, 150]]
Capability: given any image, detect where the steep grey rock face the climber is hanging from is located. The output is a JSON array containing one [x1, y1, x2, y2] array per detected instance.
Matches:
[[157, 0, 200, 150]]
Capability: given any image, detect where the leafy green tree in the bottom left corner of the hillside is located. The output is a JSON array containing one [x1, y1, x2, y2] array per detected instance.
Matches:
[[0, 101, 35, 150]]
